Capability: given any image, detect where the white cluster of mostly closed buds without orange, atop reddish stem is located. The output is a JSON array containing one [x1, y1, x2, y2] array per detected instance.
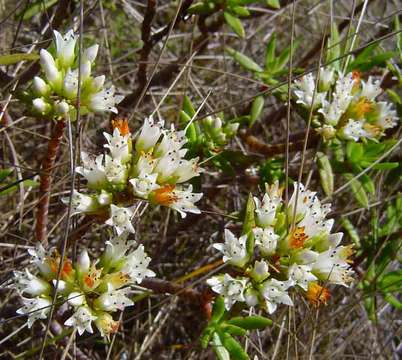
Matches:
[[32, 30, 123, 118]]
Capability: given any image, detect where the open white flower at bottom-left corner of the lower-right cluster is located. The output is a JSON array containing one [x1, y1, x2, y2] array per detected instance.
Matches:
[[207, 274, 248, 310]]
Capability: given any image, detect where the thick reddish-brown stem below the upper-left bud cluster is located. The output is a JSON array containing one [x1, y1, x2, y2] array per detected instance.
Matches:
[[35, 120, 66, 245]]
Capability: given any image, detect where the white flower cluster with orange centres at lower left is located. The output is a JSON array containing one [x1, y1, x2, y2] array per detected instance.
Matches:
[[12, 235, 155, 337]]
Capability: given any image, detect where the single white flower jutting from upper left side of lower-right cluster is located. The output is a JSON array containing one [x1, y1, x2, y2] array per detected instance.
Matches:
[[213, 229, 248, 267]]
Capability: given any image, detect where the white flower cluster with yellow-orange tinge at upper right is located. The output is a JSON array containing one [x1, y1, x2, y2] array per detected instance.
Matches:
[[293, 68, 398, 141]]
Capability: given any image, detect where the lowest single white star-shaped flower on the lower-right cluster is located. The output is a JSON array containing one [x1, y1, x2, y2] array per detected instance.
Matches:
[[261, 279, 293, 314]]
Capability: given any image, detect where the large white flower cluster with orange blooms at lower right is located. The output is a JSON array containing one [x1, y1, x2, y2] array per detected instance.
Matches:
[[207, 183, 353, 314]]
